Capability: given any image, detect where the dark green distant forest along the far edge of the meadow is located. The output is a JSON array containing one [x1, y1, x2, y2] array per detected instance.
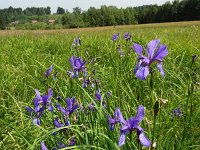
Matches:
[[0, 0, 200, 29]]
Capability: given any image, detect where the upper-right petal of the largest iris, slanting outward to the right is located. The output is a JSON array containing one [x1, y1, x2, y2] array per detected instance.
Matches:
[[152, 44, 168, 62]]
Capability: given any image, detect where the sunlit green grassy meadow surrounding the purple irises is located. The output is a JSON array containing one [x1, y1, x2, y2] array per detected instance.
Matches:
[[0, 21, 200, 150]]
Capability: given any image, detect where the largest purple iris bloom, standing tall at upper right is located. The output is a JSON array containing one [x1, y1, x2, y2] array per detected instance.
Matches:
[[133, 39, 168, 80]]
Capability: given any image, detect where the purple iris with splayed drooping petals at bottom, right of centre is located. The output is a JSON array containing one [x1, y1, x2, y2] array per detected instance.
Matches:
[[118, 106, 151, 147]]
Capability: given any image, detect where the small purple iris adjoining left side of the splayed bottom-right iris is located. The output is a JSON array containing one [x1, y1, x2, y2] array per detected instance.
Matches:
[[107, 108, 123, 130]]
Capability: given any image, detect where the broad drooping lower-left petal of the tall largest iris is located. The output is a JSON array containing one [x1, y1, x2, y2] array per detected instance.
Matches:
[[135, 66, 149, 80]]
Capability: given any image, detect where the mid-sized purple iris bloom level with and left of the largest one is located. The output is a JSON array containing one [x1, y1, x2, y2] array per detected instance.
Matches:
[[69, 56, 86, 75]]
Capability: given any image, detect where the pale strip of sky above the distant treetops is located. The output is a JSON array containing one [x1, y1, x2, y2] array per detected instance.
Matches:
[[0, 0, 173, 13]]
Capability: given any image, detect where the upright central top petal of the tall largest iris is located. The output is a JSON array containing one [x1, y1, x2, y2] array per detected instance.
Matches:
[[147, 39, 160, 59]]
